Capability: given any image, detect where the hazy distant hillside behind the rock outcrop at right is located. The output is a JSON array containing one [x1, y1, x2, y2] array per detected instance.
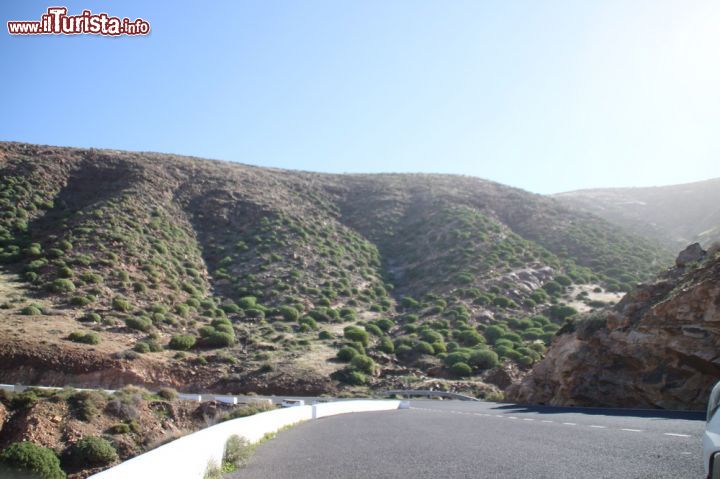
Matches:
[[554, 178, 720, 251]]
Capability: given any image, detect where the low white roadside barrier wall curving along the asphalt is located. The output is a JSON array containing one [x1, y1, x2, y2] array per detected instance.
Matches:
[[90, 400, 408, 479]]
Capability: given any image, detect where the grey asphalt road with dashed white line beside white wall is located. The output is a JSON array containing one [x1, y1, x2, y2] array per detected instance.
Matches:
[[229, 401, 705, 479]]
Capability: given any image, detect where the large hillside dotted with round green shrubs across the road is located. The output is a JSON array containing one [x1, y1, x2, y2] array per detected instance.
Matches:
[[0, 143, 670, 394]]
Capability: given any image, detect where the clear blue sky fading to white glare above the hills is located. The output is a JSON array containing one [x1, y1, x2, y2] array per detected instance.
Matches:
[[0, 0, 720, 193]]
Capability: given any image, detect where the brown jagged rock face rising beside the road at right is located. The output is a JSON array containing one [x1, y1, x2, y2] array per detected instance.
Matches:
[[506, 245, 720, 409]]
